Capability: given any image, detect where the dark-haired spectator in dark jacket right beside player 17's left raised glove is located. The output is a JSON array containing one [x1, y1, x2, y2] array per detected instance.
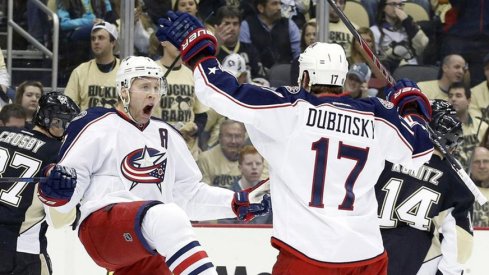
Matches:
[[214, 6, 265, 78]]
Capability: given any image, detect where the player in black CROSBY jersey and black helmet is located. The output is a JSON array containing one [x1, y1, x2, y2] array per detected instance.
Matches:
[[0, 92, 80, 275]]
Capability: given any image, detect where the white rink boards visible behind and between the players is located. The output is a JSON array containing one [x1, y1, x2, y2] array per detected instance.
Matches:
[[48, 225, 489, 275]]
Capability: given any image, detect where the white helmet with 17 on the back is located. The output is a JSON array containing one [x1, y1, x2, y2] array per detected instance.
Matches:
[[298, 42, 348, 86]]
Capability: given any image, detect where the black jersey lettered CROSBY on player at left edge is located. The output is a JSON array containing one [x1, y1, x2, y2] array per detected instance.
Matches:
[[0, 127, 61, 254]]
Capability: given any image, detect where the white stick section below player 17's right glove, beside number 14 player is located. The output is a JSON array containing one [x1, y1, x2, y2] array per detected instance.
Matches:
[[425, 124, 487, 205]]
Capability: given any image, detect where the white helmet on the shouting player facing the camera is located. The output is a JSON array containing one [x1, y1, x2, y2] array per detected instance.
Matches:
[[115, 56, 168, 97]]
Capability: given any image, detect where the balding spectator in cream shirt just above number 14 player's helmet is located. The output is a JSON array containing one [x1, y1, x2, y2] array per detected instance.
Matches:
[[418, 54, 467, 100]]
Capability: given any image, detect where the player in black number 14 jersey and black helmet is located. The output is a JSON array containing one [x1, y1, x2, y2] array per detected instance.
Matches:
[[375, 99, 474, 275]]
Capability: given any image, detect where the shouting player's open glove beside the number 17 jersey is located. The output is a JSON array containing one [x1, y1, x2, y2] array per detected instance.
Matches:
[[232, 179, 272, 222]]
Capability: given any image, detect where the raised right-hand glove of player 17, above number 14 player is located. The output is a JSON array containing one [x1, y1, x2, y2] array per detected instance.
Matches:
[[386, 78, 432, 122]]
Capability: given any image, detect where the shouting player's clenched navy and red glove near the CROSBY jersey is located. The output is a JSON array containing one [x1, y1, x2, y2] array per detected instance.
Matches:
[[38, 163, 76, 207]]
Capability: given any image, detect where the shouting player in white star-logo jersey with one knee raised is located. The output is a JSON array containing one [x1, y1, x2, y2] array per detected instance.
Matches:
[[39, 56, 270, 275]]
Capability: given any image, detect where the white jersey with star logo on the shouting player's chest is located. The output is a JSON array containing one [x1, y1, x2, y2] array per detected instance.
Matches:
[[57, 107, 235, 226]]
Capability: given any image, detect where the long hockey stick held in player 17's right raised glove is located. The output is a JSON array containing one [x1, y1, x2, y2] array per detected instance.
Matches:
[[322, 0, 487, 205]]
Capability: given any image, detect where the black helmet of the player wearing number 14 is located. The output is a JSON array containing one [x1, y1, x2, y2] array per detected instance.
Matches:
[[429, 99, 462, 150]]
